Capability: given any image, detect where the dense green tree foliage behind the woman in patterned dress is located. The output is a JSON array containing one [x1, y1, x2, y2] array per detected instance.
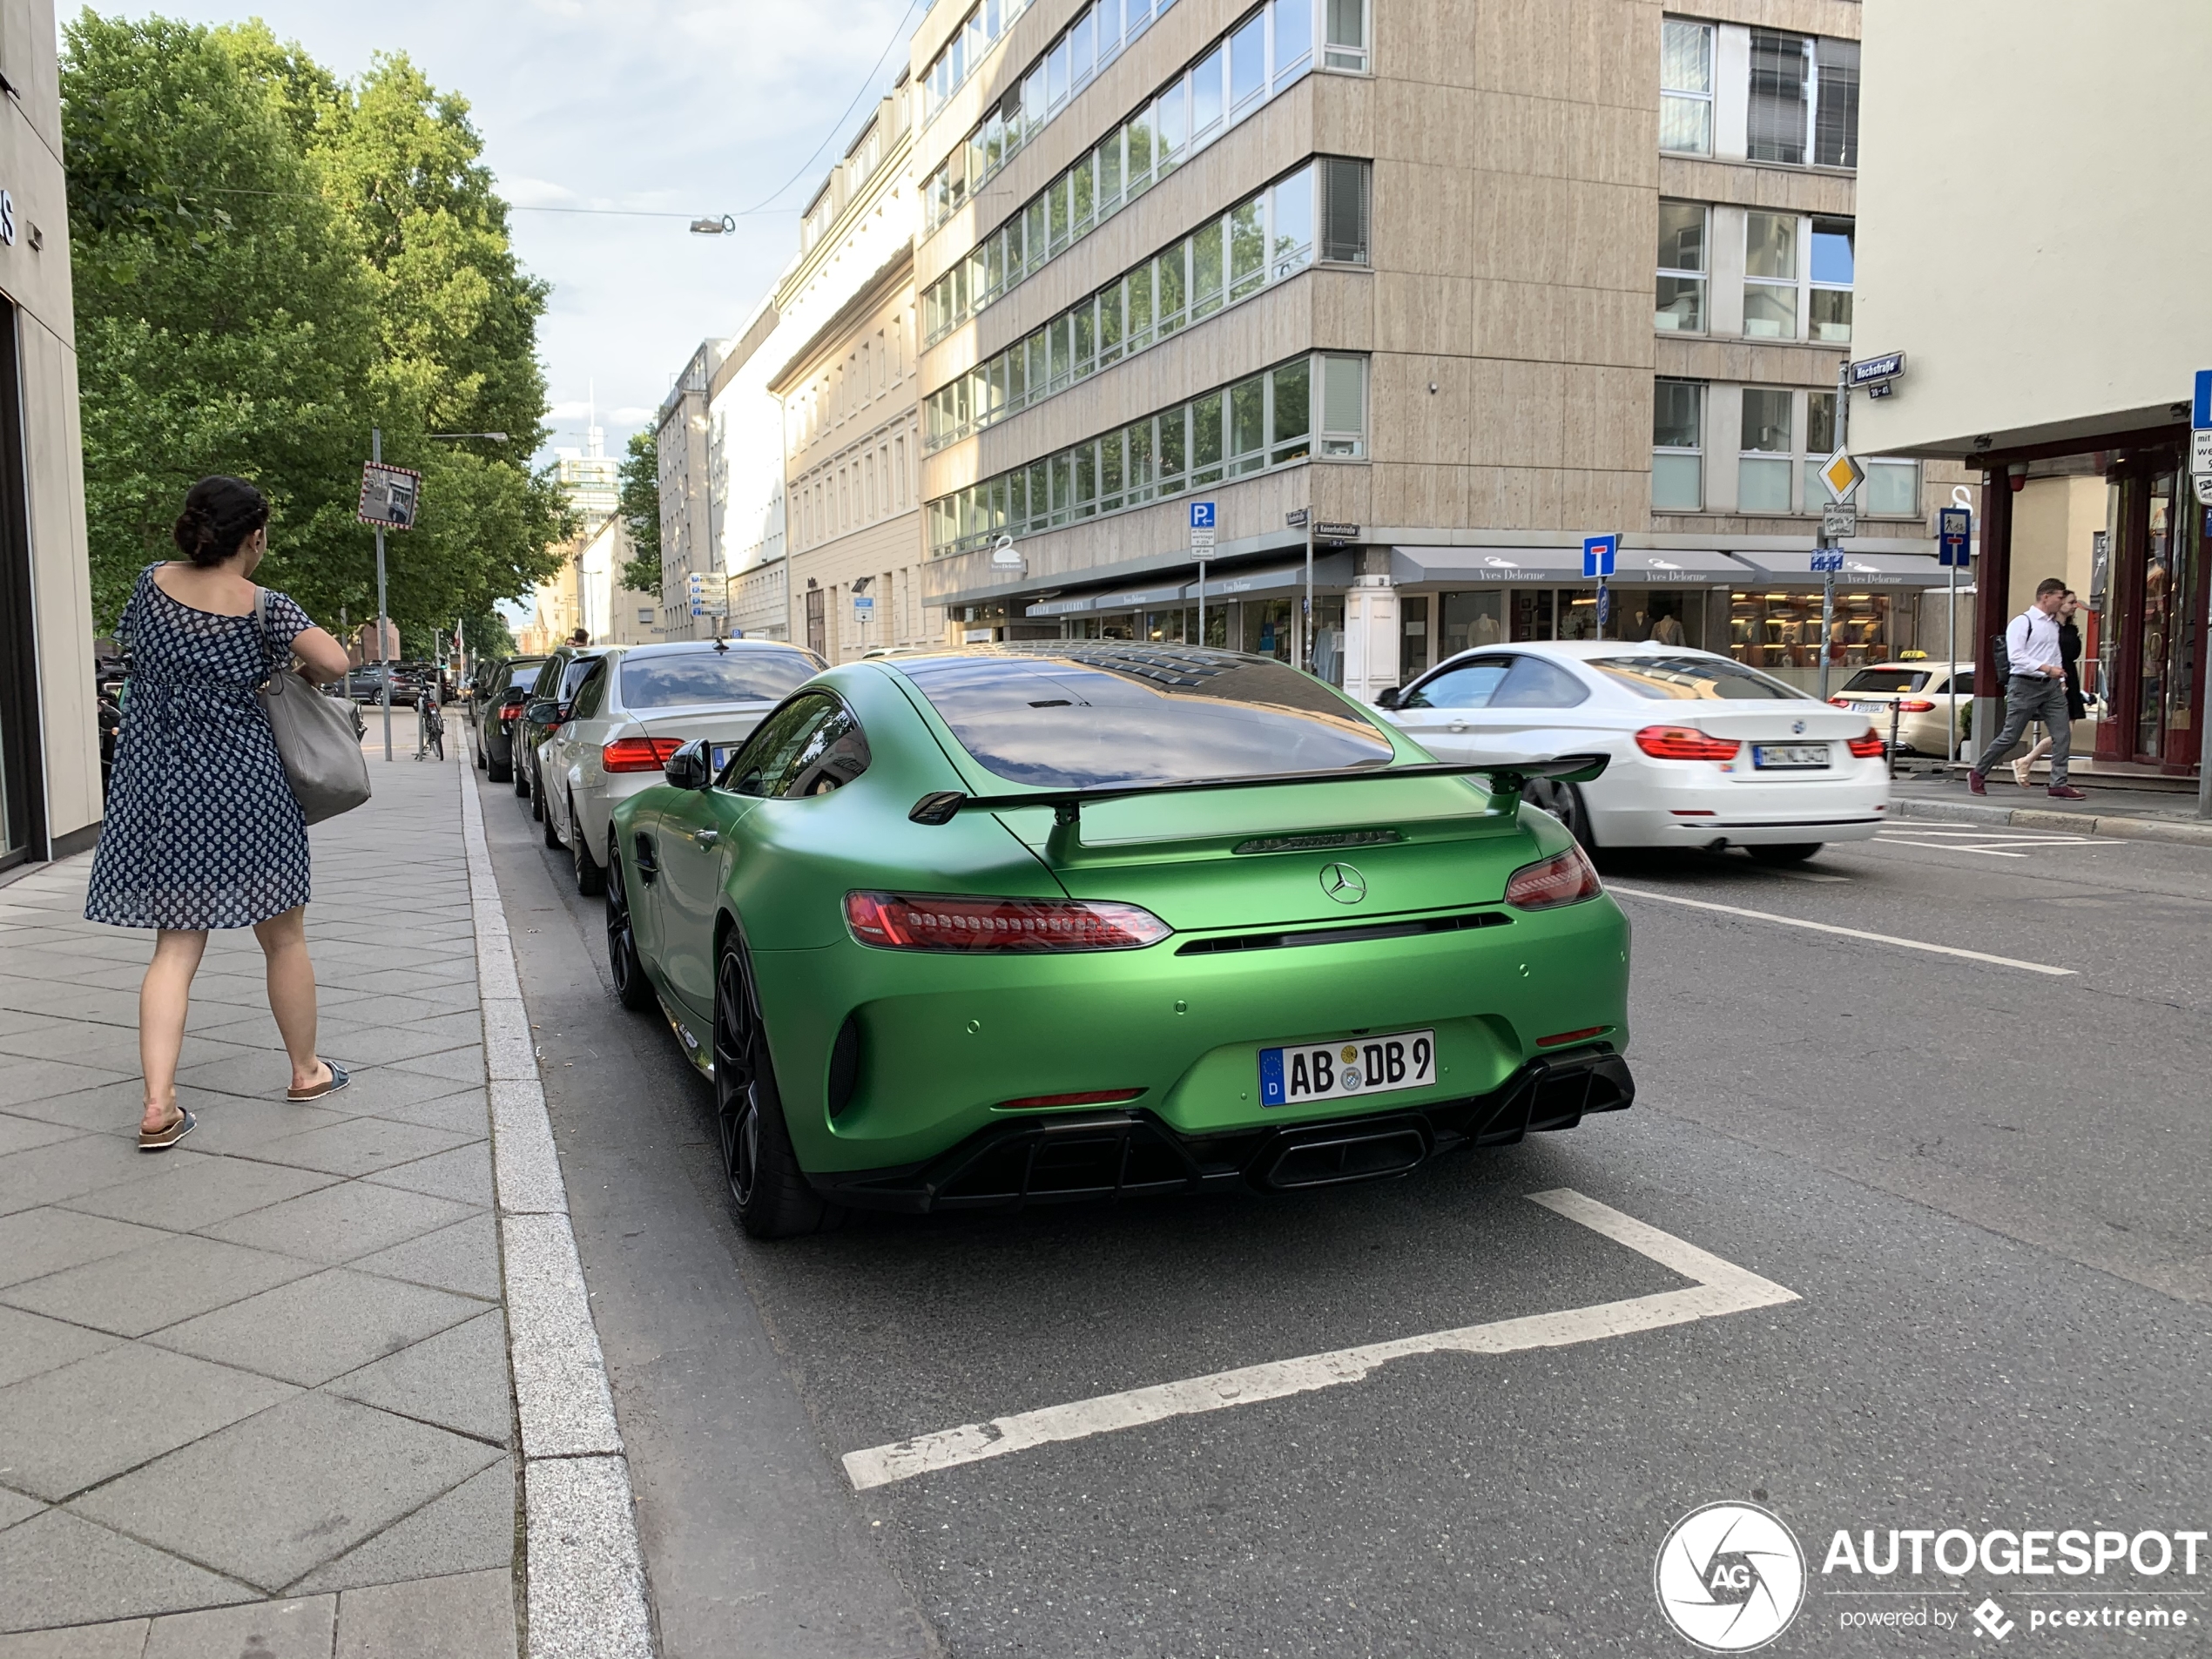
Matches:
[[62, 11, 573, 628]]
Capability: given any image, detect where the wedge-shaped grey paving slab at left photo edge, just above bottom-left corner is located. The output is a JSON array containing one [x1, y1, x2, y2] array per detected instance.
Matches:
[[0, 1508, 259, 1652]]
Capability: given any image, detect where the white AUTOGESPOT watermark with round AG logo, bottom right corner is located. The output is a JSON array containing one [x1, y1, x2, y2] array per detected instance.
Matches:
[[1652, 1494, 2212, 1652]]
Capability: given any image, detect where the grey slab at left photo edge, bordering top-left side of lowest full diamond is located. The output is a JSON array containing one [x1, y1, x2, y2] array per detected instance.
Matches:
[[0, 1343, 294, 1502]]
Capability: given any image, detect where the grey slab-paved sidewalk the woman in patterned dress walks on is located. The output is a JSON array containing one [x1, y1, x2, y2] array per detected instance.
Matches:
[[0, 752, 530, 1659]]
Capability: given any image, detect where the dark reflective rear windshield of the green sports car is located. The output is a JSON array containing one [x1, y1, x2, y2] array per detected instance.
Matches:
[[885, 642, 1393, 790]]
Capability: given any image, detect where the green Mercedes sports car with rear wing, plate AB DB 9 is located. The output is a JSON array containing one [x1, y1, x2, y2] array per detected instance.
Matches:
[[606, 639, 1635, 1237]]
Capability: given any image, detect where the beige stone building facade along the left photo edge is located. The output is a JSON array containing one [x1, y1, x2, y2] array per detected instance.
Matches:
[[0, 0, 104, 869]]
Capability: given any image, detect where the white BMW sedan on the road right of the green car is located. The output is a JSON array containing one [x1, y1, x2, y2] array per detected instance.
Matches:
[[1380, 639, 1889, 865]]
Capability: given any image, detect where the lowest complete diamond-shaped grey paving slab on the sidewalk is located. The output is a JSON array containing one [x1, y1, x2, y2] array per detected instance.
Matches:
[[71, 1393, 504, 1590]]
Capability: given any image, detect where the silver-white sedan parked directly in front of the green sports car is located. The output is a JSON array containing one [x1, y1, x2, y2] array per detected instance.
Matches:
[[537, 639, 823, 894]]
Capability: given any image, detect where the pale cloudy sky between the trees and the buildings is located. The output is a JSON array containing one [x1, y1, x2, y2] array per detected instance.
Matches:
[[105, 0, 925, 454]]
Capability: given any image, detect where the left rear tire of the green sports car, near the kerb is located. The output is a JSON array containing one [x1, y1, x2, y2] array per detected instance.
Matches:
[[714, 934, 845, 1238]]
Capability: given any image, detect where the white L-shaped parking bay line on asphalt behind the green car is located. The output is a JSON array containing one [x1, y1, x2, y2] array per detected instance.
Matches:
[[845, 1188, 1798, 1491]]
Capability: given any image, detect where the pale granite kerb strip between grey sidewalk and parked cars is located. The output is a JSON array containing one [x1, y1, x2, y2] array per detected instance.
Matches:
[[460, 738, 652, 1659]]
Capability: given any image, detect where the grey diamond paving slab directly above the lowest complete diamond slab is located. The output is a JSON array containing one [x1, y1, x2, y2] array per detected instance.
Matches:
[[159, 1267, 489, 1389]]
